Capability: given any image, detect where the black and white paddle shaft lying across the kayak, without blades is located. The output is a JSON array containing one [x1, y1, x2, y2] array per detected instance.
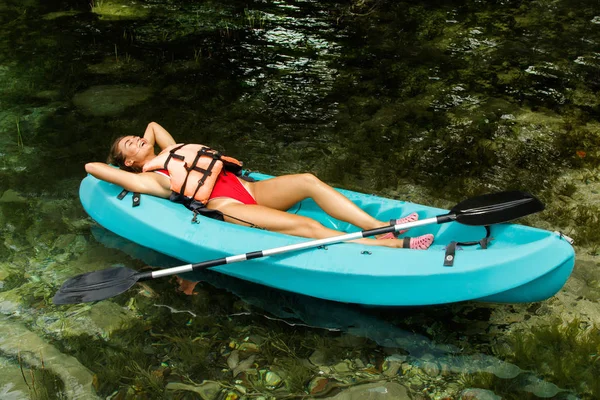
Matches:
[[138, 214, 440, 281]]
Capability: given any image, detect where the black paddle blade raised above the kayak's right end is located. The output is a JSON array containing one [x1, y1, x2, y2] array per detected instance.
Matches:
[[449, 191, 544, 226]]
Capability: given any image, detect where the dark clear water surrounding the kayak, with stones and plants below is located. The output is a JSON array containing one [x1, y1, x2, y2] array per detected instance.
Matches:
[[0, 0, 600, 399]]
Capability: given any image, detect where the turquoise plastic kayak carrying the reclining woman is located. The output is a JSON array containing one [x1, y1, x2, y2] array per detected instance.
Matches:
[[79, 173, 575, 306]]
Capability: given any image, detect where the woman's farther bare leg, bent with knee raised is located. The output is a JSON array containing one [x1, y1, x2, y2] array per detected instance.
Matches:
[[250, 174, 389, 229]]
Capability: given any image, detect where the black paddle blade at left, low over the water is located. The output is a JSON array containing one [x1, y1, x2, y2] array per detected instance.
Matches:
[[52, 267, 138, 304]]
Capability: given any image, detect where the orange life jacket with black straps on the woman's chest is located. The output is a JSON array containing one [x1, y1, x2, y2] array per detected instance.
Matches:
[[143, 144, 242, 205]]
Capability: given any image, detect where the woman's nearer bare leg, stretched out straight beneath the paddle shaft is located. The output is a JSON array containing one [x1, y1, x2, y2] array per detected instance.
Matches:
[[207, 198, 402, 248]]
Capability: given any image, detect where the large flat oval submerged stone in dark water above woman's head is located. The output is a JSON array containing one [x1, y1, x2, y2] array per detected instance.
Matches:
[[73, 85, 152, 117]]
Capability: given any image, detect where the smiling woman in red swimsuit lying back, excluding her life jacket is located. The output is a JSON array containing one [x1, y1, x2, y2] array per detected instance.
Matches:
[[85, 122, 433, 250]]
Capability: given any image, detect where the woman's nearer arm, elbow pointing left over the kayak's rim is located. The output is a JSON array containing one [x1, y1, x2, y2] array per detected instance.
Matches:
[[85, 162, 171, 198]]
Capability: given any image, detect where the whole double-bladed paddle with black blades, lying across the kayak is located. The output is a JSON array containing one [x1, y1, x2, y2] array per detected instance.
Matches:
[[53, 191, 544, 304]]
